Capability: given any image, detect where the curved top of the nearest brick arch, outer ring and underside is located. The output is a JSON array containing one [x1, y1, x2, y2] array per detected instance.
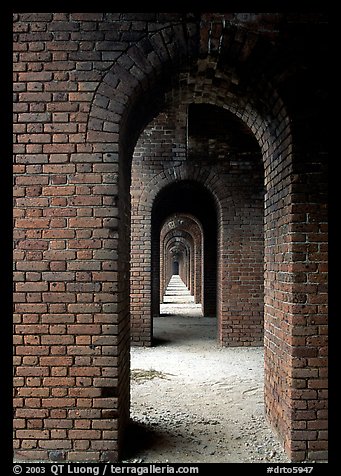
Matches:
[[87, 20, 291, 162]]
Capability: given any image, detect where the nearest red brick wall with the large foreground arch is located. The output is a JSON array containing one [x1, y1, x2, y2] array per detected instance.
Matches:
[[15, 13, 327, 461]]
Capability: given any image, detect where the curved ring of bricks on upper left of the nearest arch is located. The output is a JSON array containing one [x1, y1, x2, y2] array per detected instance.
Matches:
[[87, 23, 197, 142]]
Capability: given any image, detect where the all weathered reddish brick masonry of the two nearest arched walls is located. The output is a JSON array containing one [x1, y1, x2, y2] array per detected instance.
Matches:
[[13, 13, 328, 461]]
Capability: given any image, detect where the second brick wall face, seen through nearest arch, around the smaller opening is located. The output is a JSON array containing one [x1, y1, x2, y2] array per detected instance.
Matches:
[[132, 98, 263, 345]]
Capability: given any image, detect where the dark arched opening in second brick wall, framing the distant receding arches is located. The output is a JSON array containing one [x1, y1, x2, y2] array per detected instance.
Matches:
[[151, 180, 218, 346]]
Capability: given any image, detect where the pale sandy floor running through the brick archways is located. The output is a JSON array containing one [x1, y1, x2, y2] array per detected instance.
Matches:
[[125, 296, 289, 463]]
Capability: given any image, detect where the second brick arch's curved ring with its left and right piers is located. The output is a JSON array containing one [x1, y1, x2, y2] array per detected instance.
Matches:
[[131, 164, 263, 345]]
